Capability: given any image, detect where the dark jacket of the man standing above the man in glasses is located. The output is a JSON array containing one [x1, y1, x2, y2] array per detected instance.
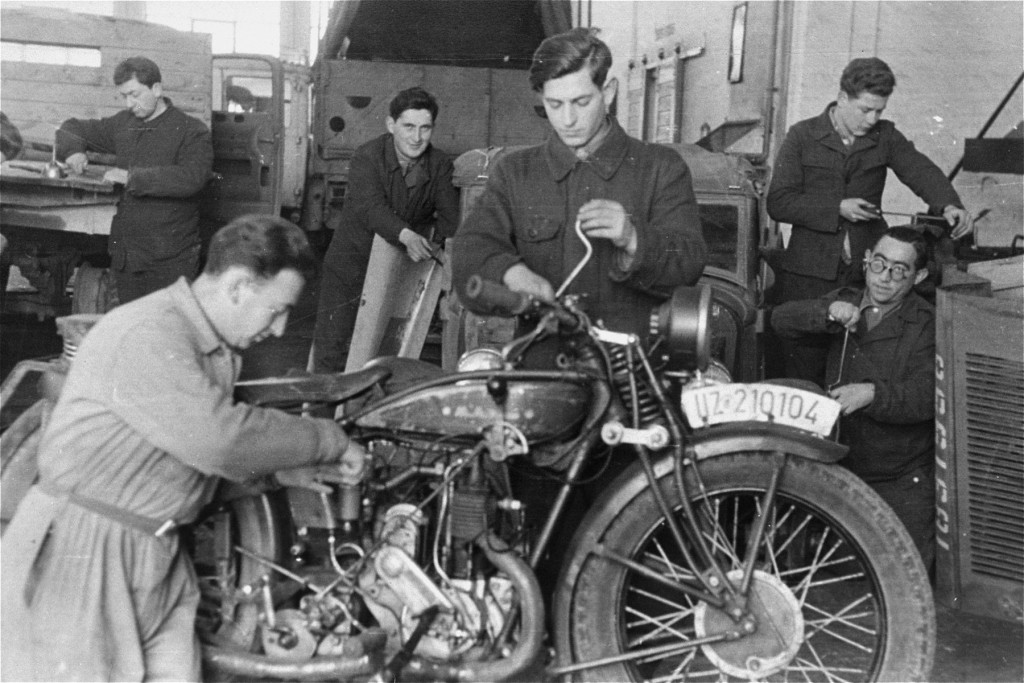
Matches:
[[768, 102, 963, 280]]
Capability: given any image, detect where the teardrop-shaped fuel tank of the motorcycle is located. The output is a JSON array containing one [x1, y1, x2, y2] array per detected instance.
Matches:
[[350, 371, 594, 444]]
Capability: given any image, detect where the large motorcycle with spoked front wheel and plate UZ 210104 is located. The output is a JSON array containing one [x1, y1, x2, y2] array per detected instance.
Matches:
[[190, 242, 936, 681]]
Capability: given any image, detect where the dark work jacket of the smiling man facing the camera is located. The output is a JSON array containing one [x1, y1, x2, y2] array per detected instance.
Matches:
[[324, 133, 459, 289]]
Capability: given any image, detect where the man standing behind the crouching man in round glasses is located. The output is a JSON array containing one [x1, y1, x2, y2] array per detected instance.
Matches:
[[768, 57, 974, 383]]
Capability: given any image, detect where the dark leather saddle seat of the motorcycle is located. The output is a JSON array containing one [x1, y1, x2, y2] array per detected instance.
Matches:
[[234, 367, 391, 407]]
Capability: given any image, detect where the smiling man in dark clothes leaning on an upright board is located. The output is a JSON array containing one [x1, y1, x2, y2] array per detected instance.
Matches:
[[313, 88, 459, 372]]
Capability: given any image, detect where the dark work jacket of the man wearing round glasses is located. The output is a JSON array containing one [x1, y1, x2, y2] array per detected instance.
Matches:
[[771, 288, 935, 482]]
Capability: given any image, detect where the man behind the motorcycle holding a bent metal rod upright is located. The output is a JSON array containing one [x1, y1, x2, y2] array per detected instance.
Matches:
[[453, 28, 707, 336]]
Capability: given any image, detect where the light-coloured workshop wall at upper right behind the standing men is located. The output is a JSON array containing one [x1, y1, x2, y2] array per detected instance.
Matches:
[[582, 0, 1024, 240]]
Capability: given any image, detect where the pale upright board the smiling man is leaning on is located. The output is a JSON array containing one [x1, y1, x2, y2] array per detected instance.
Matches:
[[345, 236, 444, 372]]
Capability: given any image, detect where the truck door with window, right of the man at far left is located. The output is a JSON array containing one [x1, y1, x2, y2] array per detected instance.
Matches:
[[204, 54, 285, 224]]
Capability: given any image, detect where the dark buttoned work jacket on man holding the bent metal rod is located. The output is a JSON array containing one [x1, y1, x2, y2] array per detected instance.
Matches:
[[453, 119, 708, 337]]
